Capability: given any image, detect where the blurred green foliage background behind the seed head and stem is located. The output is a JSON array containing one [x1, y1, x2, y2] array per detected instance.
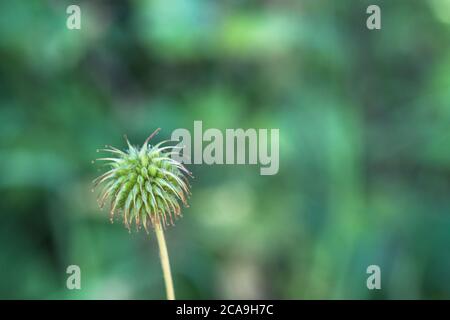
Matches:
[[0, 0, 450, 299]]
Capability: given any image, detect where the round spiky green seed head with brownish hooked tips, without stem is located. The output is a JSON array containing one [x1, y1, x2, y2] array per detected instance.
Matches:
[[94, 129, 192, 232]]
